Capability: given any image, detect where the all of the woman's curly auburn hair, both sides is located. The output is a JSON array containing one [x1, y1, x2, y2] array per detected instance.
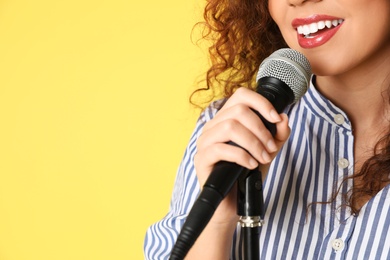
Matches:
[[194, 0, 390, 213]]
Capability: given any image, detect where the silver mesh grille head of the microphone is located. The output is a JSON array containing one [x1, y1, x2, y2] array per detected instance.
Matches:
[[256, 48, 311, 102]]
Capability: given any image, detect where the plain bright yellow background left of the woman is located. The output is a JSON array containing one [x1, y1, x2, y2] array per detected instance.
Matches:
[[0, 0, 206, 260]]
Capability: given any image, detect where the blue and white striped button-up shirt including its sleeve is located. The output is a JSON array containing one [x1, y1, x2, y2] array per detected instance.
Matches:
[[144, 79, 390, 260]]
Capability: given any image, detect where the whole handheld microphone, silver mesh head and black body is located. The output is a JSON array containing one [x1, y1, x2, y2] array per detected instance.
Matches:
[[170, 48, 311, 260]]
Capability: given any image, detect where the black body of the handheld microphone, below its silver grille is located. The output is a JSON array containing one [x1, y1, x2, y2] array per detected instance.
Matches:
[[170, 47, 307, 260]]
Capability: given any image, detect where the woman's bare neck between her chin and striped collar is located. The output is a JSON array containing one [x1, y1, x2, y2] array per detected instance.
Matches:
[[316, 48, 390, 131]]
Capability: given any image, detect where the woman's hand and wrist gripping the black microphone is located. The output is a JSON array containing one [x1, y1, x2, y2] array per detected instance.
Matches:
[[194, 88, 290, 225]]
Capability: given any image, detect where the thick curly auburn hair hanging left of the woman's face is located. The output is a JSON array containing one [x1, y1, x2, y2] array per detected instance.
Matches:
[[191, 0, 287, 103]]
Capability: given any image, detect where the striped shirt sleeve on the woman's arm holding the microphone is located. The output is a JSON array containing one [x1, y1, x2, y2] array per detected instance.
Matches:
[[144, 101, 220, 260]]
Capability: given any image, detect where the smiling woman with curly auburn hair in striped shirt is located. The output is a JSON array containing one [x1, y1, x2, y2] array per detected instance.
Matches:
[[145, 0, 390, 260]]
